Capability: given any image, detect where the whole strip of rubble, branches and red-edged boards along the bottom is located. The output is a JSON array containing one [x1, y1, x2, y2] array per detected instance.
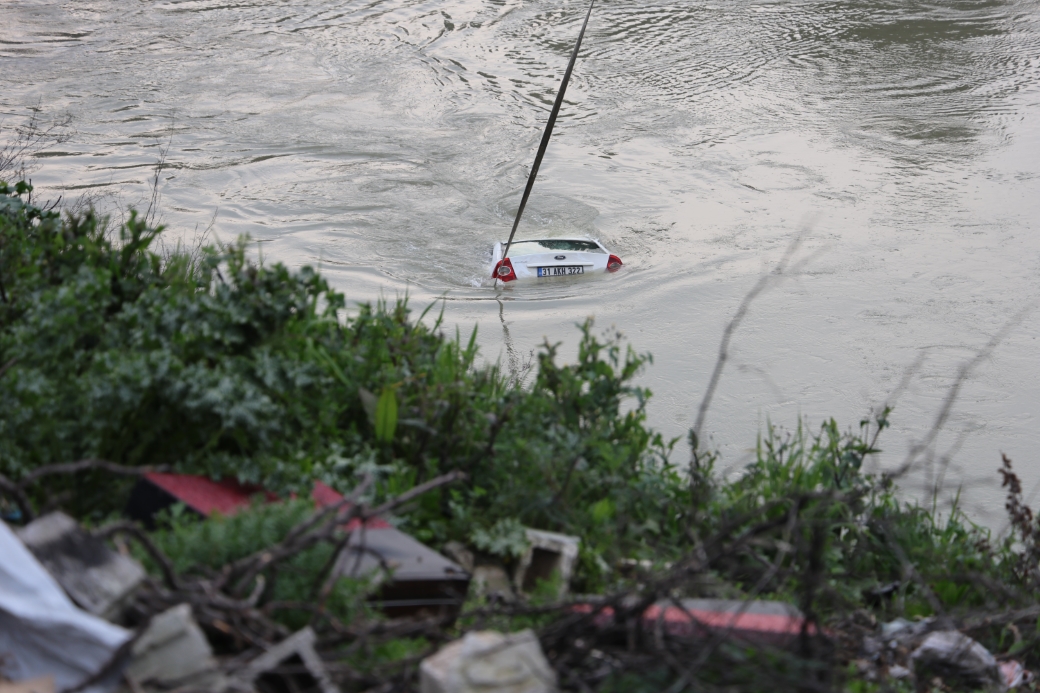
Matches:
[[0, 457, 1040, 693]]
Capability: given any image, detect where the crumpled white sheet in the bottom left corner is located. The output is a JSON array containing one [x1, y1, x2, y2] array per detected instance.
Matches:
[[0, 521, 132, 693]]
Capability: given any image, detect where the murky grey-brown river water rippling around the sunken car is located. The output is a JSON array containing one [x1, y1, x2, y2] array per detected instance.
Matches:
[[0, 0, 1040, 527]]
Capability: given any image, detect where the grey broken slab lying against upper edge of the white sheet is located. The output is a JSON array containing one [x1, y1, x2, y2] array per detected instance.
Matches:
[[17, 512, 146, 621]]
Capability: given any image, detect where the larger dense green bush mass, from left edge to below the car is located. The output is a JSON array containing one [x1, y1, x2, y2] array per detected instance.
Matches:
[[0, 181, 688, 587]]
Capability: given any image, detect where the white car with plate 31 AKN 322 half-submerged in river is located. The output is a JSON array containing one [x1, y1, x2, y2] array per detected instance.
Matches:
[[491, 238, 623, 282]]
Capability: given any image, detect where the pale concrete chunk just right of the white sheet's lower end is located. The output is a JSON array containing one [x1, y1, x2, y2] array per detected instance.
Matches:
[[125, 604, 226, 691]]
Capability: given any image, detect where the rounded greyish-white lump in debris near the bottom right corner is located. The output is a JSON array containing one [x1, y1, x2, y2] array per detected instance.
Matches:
[[910, 631, 1005, 690]]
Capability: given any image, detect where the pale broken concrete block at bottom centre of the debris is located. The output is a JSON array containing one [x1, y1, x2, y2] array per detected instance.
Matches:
[[419, 628, 556, 693]]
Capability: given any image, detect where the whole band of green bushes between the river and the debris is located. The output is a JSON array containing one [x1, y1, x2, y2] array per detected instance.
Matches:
[[0, 177, 1032, 615]]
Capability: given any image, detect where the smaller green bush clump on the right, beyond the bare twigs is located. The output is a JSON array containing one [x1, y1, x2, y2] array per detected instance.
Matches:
[[698, 411, 1017, 618]]
